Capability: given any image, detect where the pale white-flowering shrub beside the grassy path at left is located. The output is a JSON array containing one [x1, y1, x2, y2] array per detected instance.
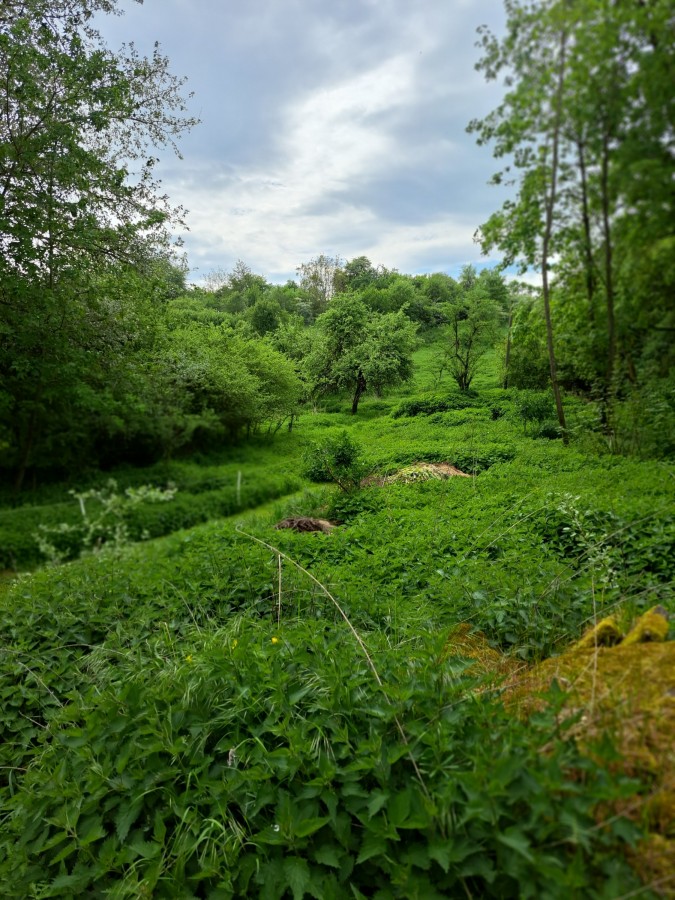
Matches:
[[35, 478, 177, 565]]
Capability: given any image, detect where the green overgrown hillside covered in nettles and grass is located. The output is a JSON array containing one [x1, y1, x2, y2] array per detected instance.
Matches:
[[0, 343, 675, 898]]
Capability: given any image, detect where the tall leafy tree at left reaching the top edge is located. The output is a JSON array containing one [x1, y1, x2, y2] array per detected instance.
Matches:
[[0, 0, 194, 490]]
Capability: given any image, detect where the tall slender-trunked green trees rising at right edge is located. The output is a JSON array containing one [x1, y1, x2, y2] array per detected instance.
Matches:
[[470, 0, 675, 437]]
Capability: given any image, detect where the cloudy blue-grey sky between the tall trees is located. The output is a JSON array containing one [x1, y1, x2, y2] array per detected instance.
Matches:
[[101, 0, 505, 283]]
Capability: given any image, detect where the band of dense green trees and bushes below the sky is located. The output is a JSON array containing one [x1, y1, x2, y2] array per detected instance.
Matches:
[[0, 239, 510, 489]]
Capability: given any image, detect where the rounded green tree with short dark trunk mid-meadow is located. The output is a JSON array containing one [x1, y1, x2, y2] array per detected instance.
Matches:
[[305, 294, 416, 415]]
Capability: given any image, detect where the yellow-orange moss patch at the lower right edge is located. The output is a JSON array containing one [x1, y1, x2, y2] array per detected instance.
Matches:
[[509, 607, 675, 896]]
